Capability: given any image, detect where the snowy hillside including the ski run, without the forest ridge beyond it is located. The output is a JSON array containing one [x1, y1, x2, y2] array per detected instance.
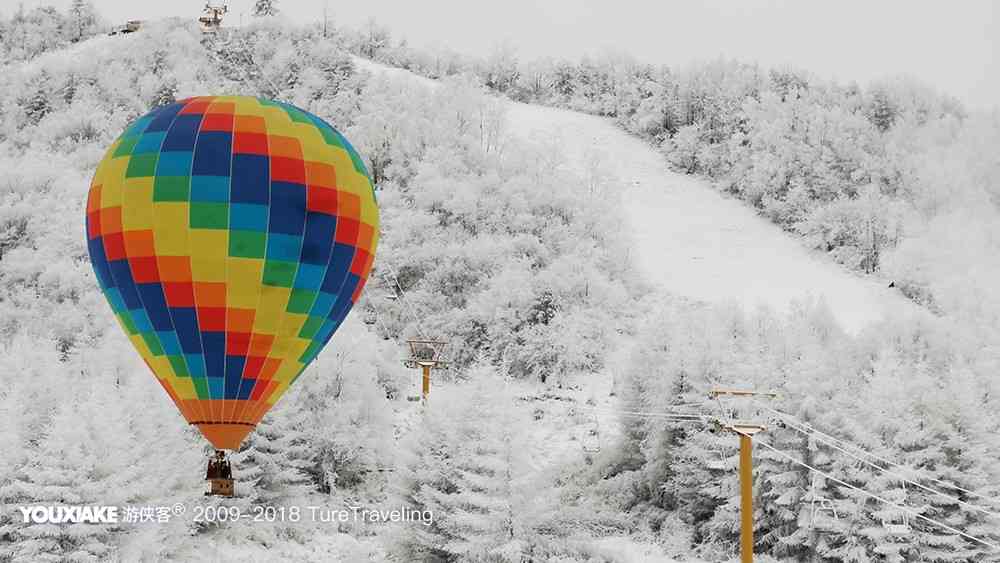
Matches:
[[0, 13, 1000, 563]]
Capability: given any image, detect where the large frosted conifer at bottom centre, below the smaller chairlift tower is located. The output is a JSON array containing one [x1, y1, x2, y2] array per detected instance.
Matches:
[[396, 368, 528, 561]]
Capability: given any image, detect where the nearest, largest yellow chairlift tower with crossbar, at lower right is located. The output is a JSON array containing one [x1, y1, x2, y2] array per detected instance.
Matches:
[[708, 388, 777, 563]]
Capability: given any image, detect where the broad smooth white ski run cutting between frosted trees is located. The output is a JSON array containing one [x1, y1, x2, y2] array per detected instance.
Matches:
[[507, 103, 916, 333]]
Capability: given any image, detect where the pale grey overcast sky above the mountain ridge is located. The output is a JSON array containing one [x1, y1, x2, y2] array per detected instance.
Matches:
[[15, 0, 1000, 108]]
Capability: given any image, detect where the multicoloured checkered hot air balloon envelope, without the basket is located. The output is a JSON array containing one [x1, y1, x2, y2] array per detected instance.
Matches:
[[87, 96, 379, 450]]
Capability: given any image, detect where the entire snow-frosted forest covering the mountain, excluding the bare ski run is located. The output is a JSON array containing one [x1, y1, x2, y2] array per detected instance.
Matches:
[[0, 2, 1000, 562]]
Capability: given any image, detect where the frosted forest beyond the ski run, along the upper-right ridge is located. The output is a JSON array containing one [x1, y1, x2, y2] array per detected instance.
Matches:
[[348, 21, 1000, 326]]
